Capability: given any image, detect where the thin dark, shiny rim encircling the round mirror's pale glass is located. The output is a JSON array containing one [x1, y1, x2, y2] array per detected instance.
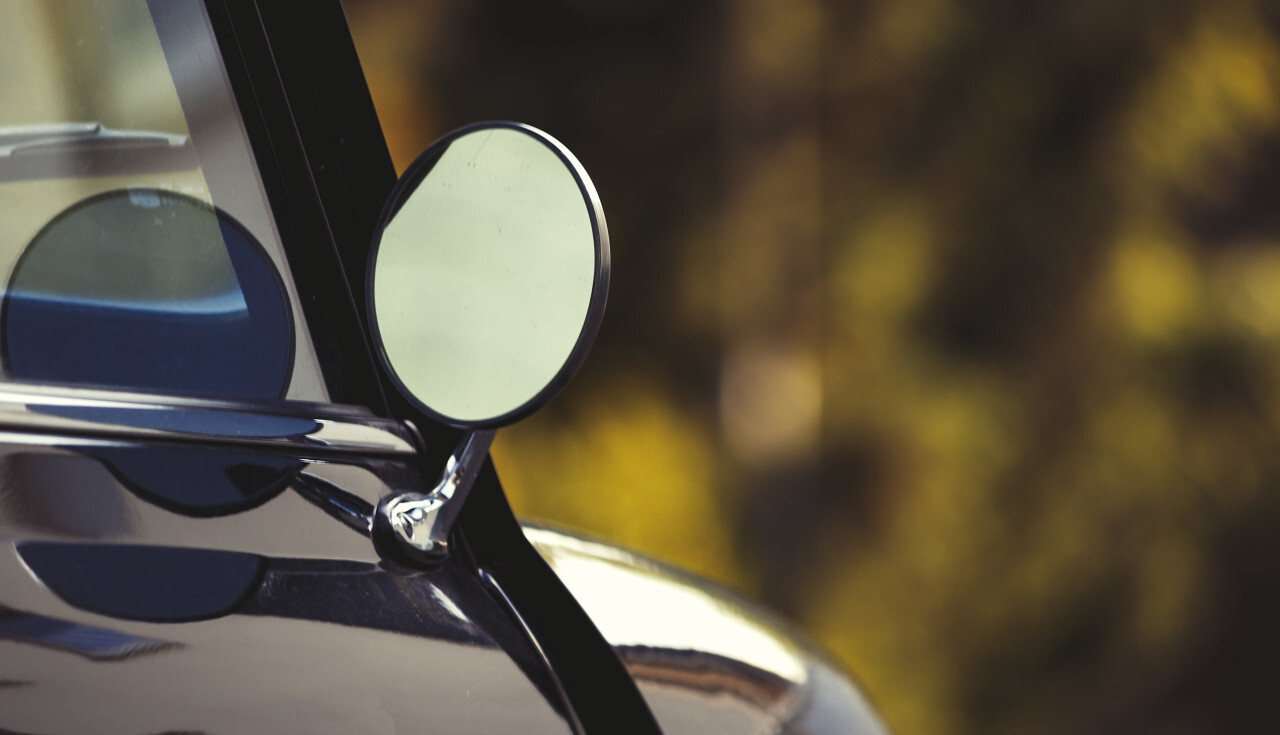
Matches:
[[365, 120, 611, 430]]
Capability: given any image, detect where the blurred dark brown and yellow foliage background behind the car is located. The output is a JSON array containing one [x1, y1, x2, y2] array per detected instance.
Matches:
[[346, 0, 1280, 735]]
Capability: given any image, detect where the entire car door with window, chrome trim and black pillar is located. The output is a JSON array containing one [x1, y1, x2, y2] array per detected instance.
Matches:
[[0, 0, 652, 732]]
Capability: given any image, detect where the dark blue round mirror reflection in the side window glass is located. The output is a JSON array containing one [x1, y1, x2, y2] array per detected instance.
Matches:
[[0, 190, 294, 400]]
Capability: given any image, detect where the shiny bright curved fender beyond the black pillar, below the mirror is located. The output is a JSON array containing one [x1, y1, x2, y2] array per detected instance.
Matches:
[[524, 524, 888, 735]]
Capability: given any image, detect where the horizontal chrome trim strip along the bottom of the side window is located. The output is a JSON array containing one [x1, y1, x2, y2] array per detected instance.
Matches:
[[0, 383, 417, 457]]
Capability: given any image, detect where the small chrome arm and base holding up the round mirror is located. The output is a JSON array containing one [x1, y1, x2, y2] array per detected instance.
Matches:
[[374, 429, 497, 563]]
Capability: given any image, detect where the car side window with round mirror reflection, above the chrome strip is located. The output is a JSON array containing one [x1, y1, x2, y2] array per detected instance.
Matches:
[[0, 0, 328, 401]]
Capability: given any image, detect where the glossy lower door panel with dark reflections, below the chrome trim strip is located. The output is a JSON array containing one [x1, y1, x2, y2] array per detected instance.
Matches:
[[0, 426, 567, 732]]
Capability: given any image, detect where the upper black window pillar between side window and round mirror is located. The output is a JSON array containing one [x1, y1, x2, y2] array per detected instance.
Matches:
[[205, 0, 396, 416]]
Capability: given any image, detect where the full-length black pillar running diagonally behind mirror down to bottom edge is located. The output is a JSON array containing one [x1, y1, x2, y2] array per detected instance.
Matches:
[[205, 0, 659, 735]]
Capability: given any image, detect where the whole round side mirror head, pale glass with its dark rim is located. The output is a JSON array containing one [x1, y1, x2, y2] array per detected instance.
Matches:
[[369, 123, 608, 428]]
